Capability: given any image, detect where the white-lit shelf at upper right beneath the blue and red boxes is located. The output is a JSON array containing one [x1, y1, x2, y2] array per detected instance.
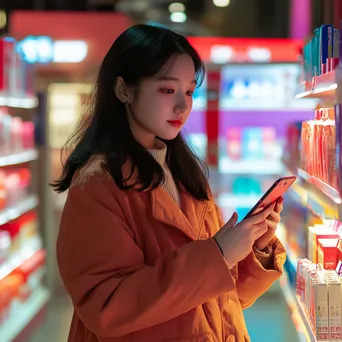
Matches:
[[295, 69, 341, 99]]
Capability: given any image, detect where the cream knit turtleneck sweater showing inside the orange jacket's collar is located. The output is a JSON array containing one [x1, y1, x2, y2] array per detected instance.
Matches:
[[148, 140, 181, 206]]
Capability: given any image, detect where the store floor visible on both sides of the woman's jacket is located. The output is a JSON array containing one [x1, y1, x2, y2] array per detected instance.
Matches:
[[25, 284, 298, 342]]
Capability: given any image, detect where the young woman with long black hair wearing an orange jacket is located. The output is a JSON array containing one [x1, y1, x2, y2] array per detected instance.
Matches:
[[54, 25, 285, 342]]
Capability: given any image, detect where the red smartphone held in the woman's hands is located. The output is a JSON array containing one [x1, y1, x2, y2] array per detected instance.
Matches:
[[245, 176, 297, 219]]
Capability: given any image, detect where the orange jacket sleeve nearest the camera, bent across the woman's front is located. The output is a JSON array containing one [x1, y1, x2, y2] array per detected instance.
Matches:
[[57, 176, 235, 337]]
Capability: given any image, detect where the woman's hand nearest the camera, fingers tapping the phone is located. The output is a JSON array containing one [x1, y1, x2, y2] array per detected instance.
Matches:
[[214, 204, 275, 268]]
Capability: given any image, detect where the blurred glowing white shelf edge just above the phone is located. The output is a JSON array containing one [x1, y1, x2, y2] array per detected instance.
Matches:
[[219, 157, 283, 175]]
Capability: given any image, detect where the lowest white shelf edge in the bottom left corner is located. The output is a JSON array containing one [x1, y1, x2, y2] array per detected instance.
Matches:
[[0, 288, 50, 342]]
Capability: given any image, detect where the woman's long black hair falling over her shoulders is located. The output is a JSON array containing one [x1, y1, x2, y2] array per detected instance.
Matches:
[[52, 25, 209, 200]]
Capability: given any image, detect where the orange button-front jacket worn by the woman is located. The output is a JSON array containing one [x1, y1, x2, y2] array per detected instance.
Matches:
[[57, 166, 285, 342]]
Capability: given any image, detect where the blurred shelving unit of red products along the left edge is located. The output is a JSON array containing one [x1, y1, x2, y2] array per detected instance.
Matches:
[[0, 38, 49, 342]]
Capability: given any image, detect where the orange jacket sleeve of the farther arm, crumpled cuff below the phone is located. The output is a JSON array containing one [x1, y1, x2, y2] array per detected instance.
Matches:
[[216, 207, 286, 309]]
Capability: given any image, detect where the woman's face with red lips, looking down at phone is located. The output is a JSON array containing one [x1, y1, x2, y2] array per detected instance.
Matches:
[[128, 54, 196, 148]]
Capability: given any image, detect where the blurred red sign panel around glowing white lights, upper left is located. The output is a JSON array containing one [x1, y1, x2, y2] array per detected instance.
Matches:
[[10, 11, 132, 77]]
